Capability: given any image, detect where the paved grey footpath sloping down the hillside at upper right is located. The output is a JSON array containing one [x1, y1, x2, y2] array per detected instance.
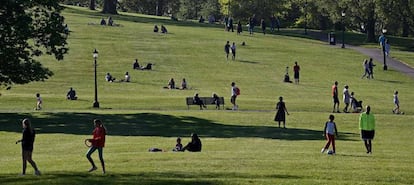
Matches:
[[308, 32, 414, 79]]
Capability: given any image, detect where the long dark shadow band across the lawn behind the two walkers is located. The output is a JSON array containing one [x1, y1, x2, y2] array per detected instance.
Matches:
[[0, 113, 357, 140]]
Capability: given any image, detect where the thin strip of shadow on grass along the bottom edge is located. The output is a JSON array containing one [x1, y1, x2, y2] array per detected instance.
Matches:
[[0, 172, 301, 185]]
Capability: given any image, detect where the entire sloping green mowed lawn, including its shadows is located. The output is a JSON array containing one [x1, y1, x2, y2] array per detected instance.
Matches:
[[0, 5, 414, 184]]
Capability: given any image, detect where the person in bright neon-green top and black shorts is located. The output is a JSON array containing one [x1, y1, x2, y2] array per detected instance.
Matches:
[[359, 105, 375, 154]]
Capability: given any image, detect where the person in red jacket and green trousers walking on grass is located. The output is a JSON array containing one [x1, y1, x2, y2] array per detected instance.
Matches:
[[86, 119, 106, 174]]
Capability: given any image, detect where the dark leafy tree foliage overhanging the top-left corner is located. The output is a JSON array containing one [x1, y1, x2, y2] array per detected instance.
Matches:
[[0, 0, 68, 87]]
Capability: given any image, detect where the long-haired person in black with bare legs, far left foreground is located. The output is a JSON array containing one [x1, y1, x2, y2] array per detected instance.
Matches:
[[16, 118, 40, 176]]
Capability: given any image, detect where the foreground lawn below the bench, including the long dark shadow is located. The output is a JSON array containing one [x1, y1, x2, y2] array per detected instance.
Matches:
[[0, 111, 414, 184]]
